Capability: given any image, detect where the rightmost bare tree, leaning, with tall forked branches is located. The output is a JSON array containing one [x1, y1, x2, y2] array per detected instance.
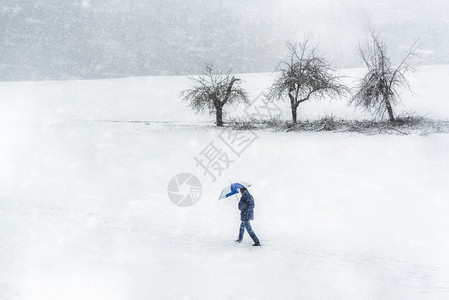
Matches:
[[350, 29, 418, 121]]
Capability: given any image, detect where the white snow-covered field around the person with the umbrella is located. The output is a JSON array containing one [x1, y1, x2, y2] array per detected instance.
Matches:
[[0, 66, 449, 300]]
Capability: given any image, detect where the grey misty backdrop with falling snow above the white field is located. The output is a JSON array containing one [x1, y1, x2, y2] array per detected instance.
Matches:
[[0, 0, 449, 81]]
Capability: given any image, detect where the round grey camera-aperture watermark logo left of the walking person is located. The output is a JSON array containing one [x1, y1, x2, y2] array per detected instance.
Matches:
[[167, 173, 202, 207]]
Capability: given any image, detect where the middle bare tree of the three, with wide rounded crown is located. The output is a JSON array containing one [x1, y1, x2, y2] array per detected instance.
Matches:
[[267, 38, 348, 123]]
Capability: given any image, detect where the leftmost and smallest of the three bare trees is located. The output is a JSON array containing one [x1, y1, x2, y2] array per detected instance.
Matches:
[[180, 64, 249, 126]]
